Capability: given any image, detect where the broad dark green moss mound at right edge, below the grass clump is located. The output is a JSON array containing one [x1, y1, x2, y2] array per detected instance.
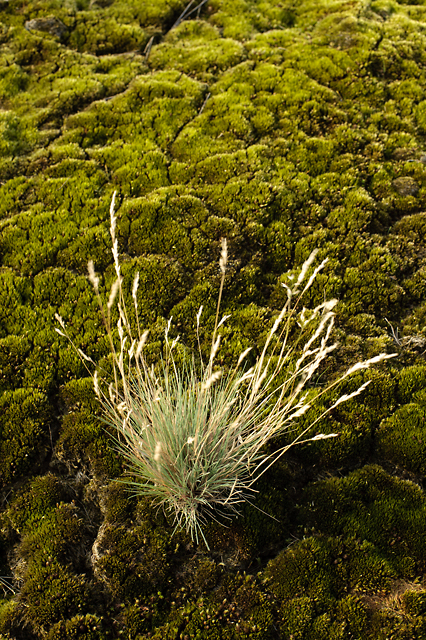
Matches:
[[302, 465, 426, 578]]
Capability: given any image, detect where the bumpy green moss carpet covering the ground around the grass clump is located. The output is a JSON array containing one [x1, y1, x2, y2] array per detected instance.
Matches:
[[0, 0, 426, 640]]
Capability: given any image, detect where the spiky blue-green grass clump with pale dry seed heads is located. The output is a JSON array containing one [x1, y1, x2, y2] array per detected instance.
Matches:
[[57, 194, 396, 545]]
